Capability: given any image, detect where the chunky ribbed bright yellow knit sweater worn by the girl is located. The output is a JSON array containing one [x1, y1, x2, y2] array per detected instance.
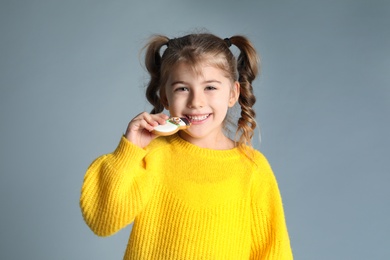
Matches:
[[80, 135, 292, 260]]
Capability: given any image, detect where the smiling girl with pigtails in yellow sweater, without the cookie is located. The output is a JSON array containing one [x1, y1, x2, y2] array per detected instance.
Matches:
[[80, 34, 292, 260]]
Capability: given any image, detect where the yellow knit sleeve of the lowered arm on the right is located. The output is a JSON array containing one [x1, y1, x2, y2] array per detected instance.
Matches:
[[251, 154, 293, 260]]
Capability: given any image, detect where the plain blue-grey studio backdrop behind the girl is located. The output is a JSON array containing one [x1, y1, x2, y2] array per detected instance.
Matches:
[[0, 0, 390, 260]]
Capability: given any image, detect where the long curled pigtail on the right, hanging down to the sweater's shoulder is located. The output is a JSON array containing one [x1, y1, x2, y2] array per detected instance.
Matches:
[[230, 36, 260, 145]]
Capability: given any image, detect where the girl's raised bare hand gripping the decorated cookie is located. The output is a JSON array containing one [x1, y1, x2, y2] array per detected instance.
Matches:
[[125, 112, 169, 148]]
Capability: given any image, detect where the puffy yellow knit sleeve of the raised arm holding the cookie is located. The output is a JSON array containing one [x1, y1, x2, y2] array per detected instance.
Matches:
[[80, 137, 153, 236]]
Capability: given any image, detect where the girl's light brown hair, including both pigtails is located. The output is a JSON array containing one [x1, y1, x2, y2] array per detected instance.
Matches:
[[145, 33, 260, 147]]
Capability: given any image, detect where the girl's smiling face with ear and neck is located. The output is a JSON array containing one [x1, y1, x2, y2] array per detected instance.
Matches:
[[165, 62, 240, 149]]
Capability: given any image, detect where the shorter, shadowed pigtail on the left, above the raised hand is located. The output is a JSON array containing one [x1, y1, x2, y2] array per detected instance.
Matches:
[[145, 35, 169, 114]]
